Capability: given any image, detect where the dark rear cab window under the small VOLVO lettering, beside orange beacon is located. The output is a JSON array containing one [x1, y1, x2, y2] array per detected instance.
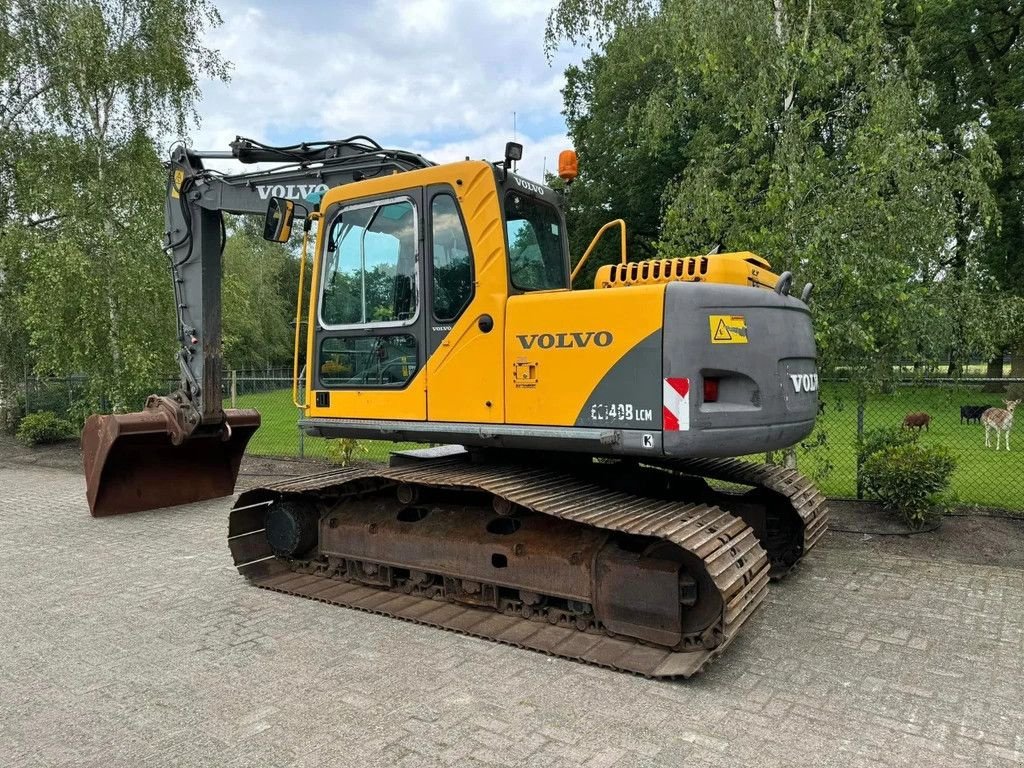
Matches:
[[505, 191, 568, 291]]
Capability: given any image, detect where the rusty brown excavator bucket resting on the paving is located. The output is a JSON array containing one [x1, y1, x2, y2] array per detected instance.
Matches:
[[82, 397, 260, 517]]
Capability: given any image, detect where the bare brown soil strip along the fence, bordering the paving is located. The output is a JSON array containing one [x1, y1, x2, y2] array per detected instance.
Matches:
[[0, 433, 1024, 569]]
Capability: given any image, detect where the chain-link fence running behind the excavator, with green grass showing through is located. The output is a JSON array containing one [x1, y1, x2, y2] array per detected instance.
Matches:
[[9, 369, 1024, 510]]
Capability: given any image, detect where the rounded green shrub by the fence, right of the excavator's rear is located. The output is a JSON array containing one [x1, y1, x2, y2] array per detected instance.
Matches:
[[861, 441, 956, 528]]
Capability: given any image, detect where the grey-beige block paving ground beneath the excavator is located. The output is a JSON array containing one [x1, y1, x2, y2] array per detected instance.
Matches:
[[0, 463, 1024, 768]]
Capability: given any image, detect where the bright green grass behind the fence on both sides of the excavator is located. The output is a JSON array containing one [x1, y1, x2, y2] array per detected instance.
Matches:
[[238, 383, 1024, 510]]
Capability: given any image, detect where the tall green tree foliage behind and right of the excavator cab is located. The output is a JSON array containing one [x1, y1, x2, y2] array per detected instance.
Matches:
[[548, 0, 1011, 389]]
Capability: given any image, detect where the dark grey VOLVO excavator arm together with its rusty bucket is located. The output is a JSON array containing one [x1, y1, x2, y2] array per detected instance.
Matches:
[[82, 136, 433, 516]]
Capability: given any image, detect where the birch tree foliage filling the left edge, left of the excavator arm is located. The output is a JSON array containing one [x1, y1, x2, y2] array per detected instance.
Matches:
[[0, 0, 226, 408]]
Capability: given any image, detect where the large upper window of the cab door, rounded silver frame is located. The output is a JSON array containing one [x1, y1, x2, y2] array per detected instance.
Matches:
[[321, 198, 418, 328]]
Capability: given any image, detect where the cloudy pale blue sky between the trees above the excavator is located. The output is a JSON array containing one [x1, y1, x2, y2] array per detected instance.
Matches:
[[190, 0, 583, 180]]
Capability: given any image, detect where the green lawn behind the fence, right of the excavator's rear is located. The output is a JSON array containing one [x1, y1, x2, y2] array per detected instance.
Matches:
[[799, 382, 1024, 511]]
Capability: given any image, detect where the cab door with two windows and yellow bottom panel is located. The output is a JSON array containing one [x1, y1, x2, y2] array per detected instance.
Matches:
[[308, 188, 427, 421]]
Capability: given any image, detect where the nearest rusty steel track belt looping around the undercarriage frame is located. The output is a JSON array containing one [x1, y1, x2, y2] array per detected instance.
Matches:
[[228, 458, 769, 677]]
